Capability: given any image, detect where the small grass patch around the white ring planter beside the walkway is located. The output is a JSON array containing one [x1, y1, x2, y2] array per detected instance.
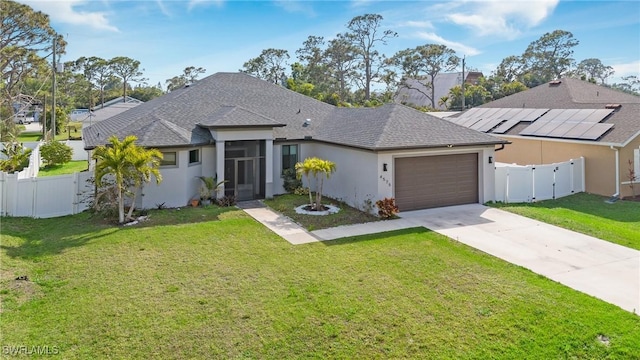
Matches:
[[264, 194, 380, 231]]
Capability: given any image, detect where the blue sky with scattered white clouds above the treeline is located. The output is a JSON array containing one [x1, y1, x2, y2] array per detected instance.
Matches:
[[19, 0, 640, 87]]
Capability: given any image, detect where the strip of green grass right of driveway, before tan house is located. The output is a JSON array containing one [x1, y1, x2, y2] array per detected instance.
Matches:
[[489, 193, 640, 250]]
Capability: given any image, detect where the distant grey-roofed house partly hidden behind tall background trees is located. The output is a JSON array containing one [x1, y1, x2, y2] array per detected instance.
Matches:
[[394, 71, 482, 110]]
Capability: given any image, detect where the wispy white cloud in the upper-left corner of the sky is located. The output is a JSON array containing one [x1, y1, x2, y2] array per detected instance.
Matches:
[[21, 0, 119, 32]]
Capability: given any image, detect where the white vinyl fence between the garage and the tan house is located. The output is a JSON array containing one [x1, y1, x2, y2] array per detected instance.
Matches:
[[495, 157, 585, 203]]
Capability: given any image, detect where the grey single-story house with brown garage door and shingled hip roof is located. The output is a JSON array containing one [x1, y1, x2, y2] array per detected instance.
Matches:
[[84, 73, 505, 210]]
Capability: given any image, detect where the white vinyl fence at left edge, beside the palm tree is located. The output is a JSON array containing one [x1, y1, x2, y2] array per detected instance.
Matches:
[[0, 171, 93, 218]]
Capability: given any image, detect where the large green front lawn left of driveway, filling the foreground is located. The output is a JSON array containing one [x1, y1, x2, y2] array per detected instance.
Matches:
[[0, 206, 640, 359]]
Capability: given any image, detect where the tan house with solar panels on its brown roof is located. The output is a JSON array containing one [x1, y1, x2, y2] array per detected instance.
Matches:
[[448, 78, 640, 197]]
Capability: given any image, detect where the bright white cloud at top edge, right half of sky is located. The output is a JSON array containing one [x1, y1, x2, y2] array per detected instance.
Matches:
[[446, 0, 559, 39]]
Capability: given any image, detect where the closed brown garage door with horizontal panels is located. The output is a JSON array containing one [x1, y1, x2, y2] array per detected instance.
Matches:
[[395, 154, 478, 211]]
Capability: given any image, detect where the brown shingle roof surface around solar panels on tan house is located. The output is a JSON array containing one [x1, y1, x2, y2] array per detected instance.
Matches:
[[450, 78, 640, 145]]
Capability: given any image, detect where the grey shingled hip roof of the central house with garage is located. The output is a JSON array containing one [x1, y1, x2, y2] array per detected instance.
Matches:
[[84, 73, 505, 150]]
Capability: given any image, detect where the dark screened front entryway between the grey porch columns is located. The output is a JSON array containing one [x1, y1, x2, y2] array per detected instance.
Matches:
[[224, 140, 266, 201]]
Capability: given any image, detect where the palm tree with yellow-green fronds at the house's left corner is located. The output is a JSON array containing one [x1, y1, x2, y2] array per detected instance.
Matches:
[[92, 135, 162, 224]]
